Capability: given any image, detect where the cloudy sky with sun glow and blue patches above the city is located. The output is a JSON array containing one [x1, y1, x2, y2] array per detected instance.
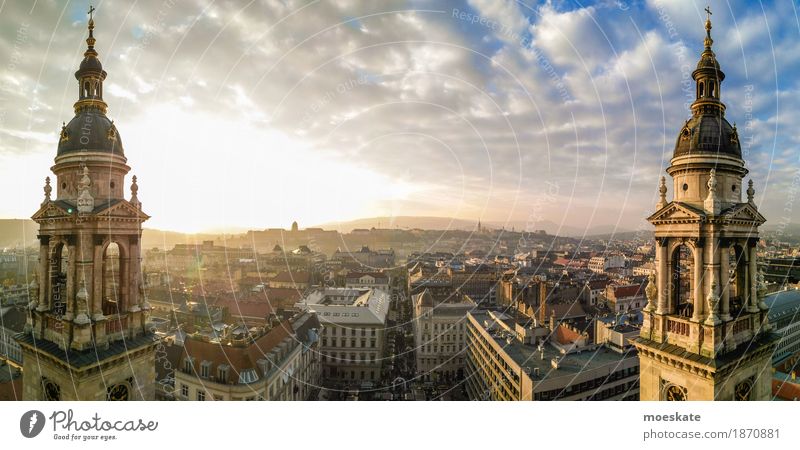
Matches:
[[0, 0, 800, 232]]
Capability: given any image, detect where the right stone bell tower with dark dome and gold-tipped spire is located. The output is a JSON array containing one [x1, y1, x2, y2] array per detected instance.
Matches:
[[634, 10, 776, 400]]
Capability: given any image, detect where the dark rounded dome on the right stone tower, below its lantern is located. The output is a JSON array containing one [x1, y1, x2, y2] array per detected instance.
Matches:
[[673, 115, 742, 158]]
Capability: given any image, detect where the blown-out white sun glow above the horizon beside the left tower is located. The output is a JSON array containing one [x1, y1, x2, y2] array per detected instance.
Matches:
[[120, 105, 419, 232]]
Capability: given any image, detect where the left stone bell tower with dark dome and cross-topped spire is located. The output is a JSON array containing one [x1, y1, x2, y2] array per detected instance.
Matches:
[[17, 9, 156, 400]]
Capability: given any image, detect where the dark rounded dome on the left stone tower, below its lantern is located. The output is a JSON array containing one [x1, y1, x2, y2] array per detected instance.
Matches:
[[58, 108, 124, 156]]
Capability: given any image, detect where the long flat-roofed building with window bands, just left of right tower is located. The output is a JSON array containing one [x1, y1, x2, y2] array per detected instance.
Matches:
[[465, 312, 639, 400]]
